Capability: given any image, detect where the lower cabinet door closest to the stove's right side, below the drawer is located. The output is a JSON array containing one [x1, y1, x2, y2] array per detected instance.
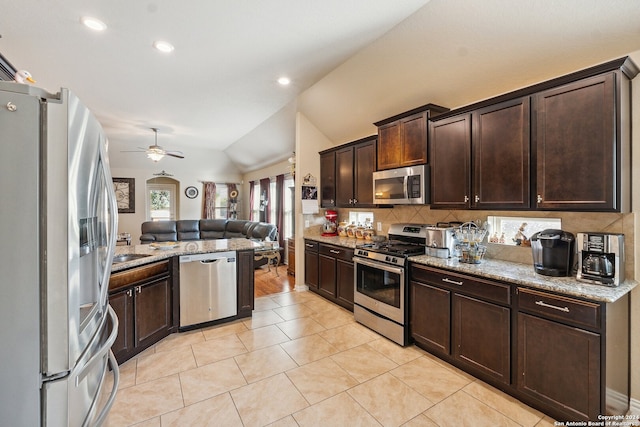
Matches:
[[409, 281, 451, 355]]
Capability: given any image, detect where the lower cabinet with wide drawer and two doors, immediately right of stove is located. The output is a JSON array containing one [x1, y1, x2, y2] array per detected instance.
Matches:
[[409, 266, 511, 384]]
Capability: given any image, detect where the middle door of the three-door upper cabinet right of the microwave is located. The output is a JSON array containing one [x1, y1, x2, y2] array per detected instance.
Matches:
[[472, 97, 531, 209]]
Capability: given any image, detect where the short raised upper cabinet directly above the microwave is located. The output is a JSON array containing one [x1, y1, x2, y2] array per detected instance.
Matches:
[[374, 104, 449, 170]]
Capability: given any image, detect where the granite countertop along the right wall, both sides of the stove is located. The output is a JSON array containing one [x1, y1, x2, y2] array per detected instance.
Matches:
[[304, 235, 638, 303]]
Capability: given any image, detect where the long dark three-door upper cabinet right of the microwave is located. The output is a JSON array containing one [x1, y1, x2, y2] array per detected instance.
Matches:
[[429, 57, 639, 212]]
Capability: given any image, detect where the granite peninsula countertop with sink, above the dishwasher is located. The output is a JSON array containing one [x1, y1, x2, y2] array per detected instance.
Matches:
[[111, 238, 264, 273]]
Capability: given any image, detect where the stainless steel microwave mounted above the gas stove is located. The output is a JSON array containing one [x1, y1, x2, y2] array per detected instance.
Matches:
[[373, 165, 430, 205]]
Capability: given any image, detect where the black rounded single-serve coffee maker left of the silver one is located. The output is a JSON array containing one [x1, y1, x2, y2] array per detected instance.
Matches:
[[531, 229, 575, 277]]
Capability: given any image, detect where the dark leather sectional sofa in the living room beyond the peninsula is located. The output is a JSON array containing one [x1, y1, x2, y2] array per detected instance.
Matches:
[[140, 219, 278, 244]]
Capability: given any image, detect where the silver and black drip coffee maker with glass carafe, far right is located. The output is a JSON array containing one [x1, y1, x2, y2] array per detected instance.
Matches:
[[576, 233, 624, 286]]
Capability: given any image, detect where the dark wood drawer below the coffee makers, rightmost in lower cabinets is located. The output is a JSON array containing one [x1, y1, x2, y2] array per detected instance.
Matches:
[[518, 288, 601, 329]]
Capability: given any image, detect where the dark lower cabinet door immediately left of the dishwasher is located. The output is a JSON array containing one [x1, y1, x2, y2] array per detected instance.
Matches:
[[134, 278, 171, 347]]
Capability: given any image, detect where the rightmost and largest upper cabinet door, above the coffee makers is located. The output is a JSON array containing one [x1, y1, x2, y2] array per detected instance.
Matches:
[[535, 73, 619, 210]]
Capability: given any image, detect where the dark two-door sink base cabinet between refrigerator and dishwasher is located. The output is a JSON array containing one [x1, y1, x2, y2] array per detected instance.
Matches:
[[109, 260, 175, 363]]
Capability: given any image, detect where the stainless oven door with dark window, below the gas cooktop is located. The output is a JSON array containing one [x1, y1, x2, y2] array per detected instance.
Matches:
[[353, 257, 405, 325]]
